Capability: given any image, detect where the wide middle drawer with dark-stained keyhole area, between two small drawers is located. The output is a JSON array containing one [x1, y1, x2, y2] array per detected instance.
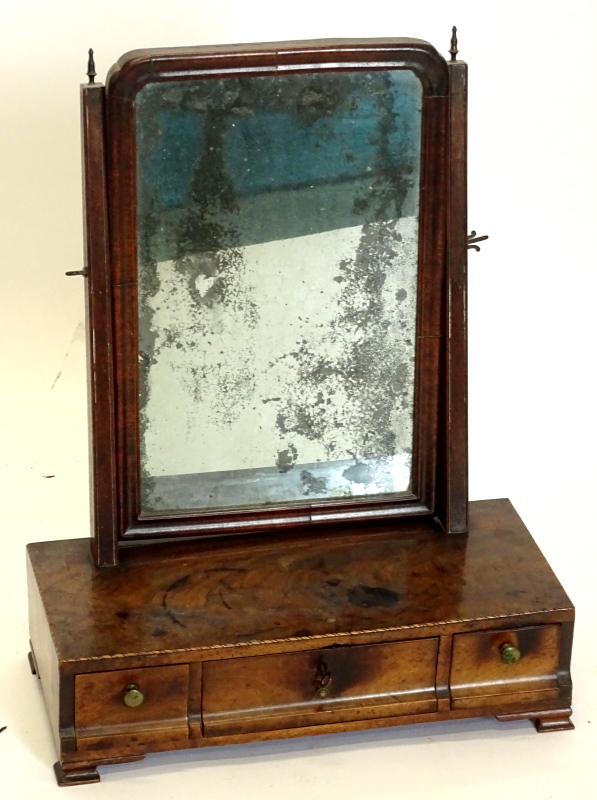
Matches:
[[203, 639, 438, 736]]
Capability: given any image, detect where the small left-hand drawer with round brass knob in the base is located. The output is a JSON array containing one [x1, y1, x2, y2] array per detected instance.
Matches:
[[75, 664, 189, 745]]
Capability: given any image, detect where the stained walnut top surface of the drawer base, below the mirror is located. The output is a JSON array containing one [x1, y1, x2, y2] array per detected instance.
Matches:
[[28, 500, 572, 661]]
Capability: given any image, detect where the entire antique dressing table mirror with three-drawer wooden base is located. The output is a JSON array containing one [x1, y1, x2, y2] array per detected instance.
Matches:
[[28, 31, 574, 785]]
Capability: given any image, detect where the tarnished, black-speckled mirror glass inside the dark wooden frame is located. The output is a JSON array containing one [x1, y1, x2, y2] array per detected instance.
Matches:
[[136, 70, 422, 513]]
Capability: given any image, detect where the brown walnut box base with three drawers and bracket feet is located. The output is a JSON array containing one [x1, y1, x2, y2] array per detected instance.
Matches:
[[29, 500, 574, 785]]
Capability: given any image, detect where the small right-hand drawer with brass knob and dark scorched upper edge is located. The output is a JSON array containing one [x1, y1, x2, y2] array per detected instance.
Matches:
[[450, 625, 560, 708]]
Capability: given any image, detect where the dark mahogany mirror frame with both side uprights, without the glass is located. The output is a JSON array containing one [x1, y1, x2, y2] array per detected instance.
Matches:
[[82, 39, 468, 566]]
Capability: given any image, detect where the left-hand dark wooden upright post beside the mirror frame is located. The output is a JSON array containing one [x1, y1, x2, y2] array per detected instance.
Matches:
[[81, 76, 118, 567]]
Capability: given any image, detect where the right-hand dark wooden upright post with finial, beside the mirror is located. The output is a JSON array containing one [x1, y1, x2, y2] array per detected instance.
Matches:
[[439, 42, 468, 533]]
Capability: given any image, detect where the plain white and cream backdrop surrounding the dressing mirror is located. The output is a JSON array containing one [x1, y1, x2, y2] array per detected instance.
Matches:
[[0, 0, 597, 800]]
